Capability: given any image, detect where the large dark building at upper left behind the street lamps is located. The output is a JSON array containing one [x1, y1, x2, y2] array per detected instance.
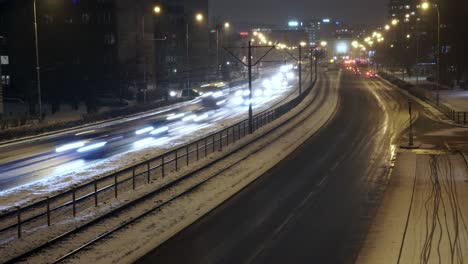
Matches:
[[0, 0, 209, 113]]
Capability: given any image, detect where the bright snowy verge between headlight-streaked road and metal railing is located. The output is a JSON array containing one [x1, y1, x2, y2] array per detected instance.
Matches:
[[0, 65, 307, 212]]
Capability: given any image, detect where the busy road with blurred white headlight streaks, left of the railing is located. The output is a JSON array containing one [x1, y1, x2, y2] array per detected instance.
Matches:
[[0, 65, 308, 194]]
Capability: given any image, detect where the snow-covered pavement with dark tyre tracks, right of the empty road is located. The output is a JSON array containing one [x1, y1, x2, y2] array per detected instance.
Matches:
[[356, 152, 468, 264]]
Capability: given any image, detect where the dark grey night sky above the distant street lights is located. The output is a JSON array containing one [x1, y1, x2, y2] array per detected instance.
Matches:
[[210, 0, 389, 25]]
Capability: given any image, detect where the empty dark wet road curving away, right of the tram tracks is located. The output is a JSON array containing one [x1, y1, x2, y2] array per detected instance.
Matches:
[[137, 70, 406, 264]]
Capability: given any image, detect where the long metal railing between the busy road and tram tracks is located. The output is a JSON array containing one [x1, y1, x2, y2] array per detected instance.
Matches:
[[0, 73, 316, 242]]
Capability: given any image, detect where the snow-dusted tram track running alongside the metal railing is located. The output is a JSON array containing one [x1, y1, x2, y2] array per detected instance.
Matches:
[[5, 74, 330, 263]]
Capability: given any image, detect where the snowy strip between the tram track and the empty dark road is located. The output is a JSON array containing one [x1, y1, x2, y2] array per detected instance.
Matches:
[[51, 71, 339, 263]]
